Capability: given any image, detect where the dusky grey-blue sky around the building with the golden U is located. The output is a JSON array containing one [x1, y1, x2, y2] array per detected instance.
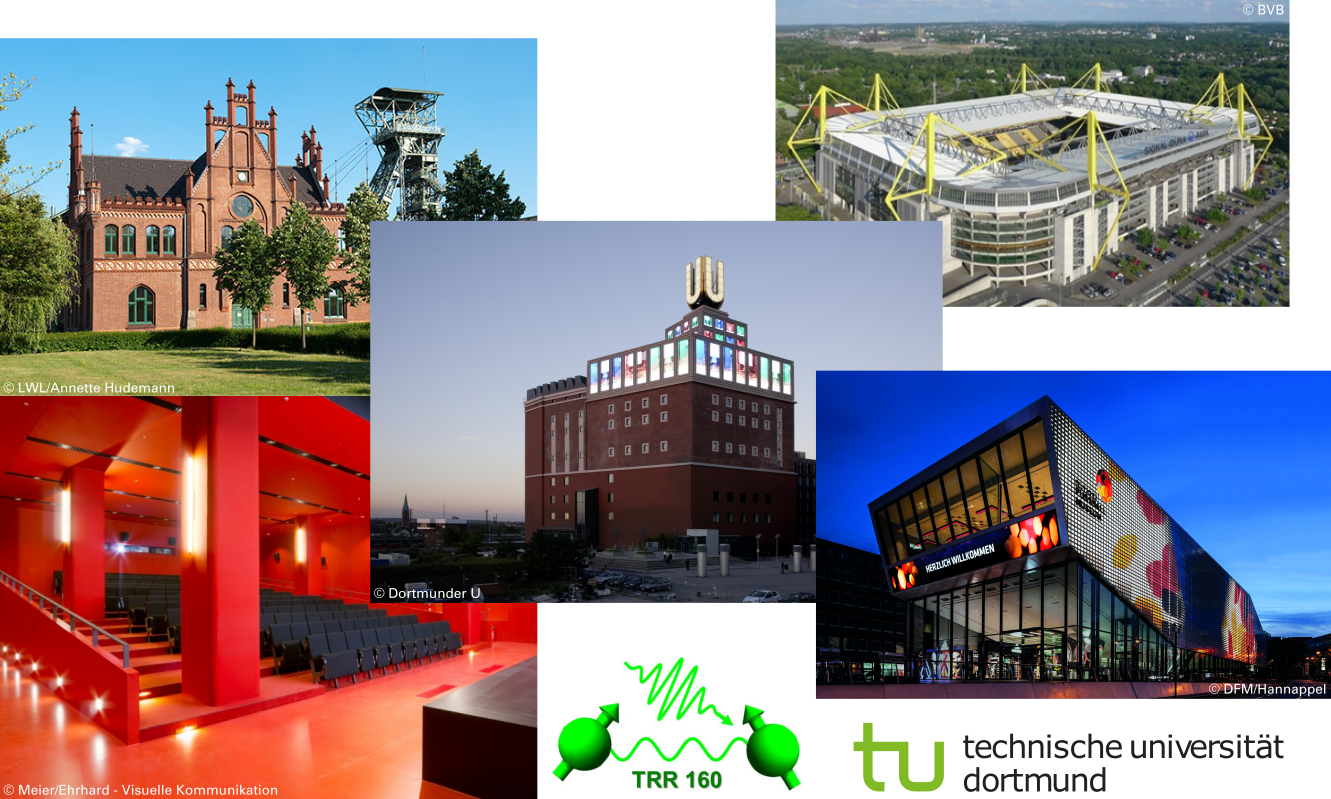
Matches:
[[370, 220, 942, 519]]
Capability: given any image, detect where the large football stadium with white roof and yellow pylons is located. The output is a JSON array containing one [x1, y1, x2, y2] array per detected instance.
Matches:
[[789, 64, 1271, 285]]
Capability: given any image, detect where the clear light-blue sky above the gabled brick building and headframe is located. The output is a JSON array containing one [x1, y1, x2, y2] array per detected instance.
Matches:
[[0, 37, 538, 216]]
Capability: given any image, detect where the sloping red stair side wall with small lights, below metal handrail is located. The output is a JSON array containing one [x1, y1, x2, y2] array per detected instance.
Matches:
[[0, 586, 138, 743]]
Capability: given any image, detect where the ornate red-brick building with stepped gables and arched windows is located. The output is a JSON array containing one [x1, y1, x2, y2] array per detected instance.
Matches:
[[61, 80, 370, 330]]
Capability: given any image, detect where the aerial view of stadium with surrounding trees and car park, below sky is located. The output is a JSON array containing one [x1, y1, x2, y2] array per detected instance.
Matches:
[[775, 17, 1291, 308]]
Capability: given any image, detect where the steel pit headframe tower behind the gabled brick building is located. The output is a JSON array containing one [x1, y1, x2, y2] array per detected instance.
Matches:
[[355, 87, 445, 220]]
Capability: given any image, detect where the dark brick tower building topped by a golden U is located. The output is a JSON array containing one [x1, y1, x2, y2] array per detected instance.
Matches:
[[524, 258, 796, 557]]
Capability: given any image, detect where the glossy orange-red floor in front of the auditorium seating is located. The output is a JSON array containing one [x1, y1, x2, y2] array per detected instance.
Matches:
[[0, 642, 536, 799]]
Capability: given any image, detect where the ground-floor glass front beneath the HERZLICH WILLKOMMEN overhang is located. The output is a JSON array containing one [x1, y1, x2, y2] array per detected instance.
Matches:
[[905, 562, 1251, 680]]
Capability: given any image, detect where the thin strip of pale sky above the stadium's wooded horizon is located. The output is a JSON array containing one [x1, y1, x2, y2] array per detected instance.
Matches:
[[776, 0, 1290, 25]]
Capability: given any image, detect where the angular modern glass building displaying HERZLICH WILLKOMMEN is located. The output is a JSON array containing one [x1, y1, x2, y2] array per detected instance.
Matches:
[[870, 398, 1266, 680]]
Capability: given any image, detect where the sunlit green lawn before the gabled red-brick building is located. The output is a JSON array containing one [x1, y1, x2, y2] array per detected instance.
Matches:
[[0, 348, 370, 396]]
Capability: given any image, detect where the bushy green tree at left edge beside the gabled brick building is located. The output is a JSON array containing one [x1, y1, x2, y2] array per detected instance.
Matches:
[[0, 190, 79, 352]]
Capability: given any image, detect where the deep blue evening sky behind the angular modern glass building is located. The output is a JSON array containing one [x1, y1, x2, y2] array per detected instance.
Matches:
[[817, 372, 1331, 635]]
